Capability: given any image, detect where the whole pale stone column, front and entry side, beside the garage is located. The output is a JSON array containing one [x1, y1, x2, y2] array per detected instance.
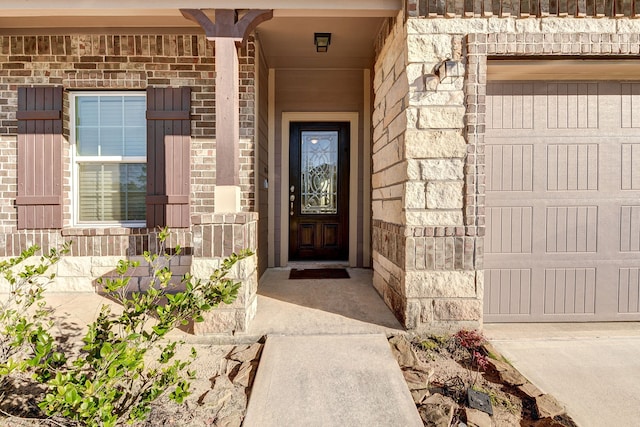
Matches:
[[373, 14, 482, 331]]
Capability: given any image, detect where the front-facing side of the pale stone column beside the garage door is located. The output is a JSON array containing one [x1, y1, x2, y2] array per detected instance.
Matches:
[[404, 19, 482, 329]]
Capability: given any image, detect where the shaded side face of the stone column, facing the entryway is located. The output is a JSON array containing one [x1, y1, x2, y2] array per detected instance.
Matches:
[[371, 15, 414, 327]]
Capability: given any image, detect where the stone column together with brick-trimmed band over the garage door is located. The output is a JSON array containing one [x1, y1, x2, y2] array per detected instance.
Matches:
[[373, 7, 640, 331]]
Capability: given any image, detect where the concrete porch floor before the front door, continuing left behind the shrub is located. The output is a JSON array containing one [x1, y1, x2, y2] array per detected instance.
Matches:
[[38, 265, 404, 343]]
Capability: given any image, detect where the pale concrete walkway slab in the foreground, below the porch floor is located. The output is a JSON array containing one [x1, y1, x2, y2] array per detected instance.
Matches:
[[243, 334, 423, 427]]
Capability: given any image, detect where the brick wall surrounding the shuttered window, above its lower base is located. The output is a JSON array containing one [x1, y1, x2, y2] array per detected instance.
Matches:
[[0, 34, 255, 256]]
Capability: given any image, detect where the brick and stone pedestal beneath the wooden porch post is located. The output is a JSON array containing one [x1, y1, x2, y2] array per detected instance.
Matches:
[[191, 213, 258, 335]]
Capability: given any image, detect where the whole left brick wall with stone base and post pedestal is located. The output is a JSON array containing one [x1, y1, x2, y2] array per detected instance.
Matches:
[[0, 34, 257, 333]]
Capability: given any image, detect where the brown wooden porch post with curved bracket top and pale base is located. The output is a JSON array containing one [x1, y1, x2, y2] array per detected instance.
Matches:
[[180, 9, 273, 212]]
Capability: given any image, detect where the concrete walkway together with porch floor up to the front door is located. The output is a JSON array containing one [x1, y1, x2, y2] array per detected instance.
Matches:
[[243, 266, 422, 427]]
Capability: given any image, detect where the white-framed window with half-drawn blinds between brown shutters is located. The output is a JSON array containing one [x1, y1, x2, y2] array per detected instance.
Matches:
[[72, 92, 147, 226]]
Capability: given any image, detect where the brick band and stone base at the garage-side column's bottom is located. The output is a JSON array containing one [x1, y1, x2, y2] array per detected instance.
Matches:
[[373, 220, 483, 334]]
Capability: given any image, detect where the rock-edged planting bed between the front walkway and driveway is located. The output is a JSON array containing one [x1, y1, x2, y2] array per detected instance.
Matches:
[[389, 336, 576, 427]]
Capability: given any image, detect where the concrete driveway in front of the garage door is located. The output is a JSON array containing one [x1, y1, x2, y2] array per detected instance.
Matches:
[[484, 322, 640, 427]]
